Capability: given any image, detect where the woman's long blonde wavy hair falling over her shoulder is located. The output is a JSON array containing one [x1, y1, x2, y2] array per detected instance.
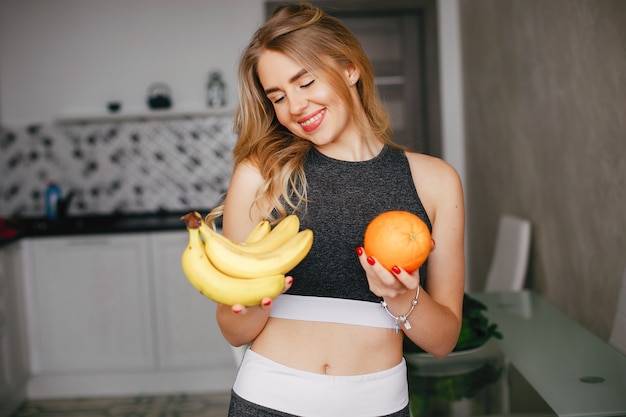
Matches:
[[209, 3, 397, 222]]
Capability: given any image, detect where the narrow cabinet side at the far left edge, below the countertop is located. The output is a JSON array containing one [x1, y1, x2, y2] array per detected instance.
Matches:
[[0, 243, 28, 417]]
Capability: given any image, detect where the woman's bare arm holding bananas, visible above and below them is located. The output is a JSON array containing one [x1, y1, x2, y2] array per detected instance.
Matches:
[[216, 161, 286, 346]]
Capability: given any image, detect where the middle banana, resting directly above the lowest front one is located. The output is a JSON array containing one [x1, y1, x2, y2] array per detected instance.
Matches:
[[204, 229, 313, 278]]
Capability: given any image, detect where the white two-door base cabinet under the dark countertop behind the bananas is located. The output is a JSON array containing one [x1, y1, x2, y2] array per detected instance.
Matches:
[[25, 231, 235, 398]]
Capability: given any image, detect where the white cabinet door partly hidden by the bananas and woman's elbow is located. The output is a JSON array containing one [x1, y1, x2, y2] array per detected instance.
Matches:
[[151, 230, 235, 375]]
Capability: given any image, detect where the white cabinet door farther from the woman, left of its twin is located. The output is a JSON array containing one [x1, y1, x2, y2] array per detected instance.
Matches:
[[29, 235, 154, 374]]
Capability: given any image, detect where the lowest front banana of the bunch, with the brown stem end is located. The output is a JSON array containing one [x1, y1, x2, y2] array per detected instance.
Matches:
[[181, 213, 285, 307]]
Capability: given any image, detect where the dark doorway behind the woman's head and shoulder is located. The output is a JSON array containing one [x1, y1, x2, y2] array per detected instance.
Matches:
[[266, 0, 441, 157]]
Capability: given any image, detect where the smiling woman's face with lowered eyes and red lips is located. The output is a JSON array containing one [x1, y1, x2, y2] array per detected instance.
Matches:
[[257, 50, 359, 148]]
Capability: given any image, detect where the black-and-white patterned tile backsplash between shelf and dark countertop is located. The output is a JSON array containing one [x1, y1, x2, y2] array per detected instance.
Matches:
[[0, 114, 236, 216]]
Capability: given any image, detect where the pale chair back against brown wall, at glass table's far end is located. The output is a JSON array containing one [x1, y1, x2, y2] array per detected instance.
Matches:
[[485, 215, 531, 292]]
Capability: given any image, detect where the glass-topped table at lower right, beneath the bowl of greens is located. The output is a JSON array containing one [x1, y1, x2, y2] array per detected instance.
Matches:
[[405, 291, 626, 417]]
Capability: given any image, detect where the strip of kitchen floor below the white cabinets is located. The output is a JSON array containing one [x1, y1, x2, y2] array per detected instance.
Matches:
[[11, 393, 230, 417]]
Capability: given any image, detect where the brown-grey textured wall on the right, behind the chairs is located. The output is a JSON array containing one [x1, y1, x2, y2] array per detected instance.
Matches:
[[461, 0, 626, 338]]
